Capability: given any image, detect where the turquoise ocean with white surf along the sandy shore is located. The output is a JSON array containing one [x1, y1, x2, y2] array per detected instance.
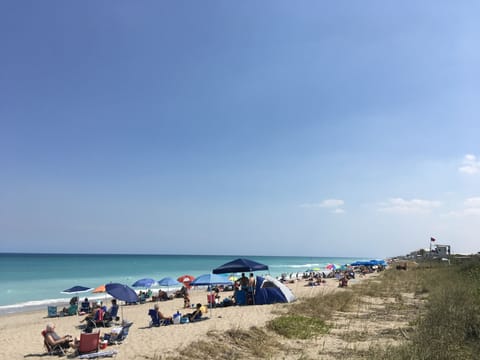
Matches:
[[0, 253, 368, 315]]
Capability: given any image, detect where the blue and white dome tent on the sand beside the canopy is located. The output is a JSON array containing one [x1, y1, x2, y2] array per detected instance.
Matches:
[[255, 275, 296, 305]]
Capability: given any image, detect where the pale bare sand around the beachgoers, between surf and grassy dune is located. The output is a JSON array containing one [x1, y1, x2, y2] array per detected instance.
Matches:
[[0, 279, 352, 360]]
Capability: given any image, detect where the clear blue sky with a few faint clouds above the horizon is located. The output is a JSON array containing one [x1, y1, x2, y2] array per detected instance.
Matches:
[[0, 1, 480, 257]]
